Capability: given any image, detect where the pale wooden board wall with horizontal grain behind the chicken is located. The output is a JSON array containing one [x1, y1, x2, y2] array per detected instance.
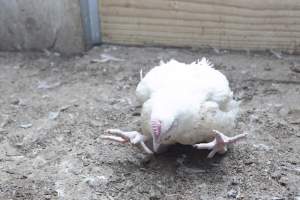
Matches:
[[99, 0, 300, 53]]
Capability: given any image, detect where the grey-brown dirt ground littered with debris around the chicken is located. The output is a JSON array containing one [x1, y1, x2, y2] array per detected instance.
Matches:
[[0, 46, 300, 200]]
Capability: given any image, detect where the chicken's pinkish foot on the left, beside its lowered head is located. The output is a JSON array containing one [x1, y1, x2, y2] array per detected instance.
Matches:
[[100, 129, 153, 154]]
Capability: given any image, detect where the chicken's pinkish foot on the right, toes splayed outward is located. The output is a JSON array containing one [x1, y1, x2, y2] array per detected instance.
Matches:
[[193, 130, 248, 158]]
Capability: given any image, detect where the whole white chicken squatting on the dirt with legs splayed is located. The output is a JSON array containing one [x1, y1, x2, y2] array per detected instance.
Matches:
[[101, 58, 247, 158]]
